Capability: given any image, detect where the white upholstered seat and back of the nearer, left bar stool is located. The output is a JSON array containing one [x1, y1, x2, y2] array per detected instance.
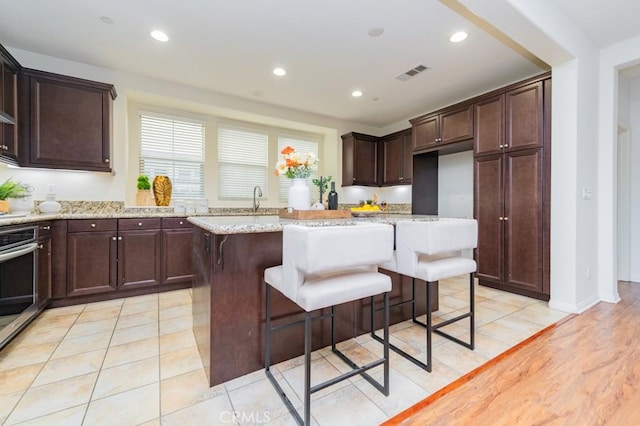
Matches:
[[264, 223, 393, 312]]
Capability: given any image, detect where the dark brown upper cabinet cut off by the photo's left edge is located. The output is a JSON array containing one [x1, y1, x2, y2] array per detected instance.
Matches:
[[0, 46, 20, 164]]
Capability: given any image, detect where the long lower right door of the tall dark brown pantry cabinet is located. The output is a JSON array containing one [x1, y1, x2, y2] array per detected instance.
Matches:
[[504, 149, 543, 292]]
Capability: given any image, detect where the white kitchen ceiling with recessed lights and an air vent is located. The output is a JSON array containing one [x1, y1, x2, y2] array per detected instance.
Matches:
[[0, 0, 640, 127]]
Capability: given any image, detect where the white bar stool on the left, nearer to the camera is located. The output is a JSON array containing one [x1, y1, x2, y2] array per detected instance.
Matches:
[[264, 223, 393, 425]]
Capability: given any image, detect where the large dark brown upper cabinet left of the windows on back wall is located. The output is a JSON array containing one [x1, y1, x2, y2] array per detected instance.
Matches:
[[18, 69, 116, 172]]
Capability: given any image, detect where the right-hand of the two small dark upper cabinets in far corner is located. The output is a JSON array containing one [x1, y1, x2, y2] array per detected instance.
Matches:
[[381, 129, 413, 186]]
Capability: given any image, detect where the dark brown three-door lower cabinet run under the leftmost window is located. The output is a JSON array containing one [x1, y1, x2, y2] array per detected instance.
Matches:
[[65, 218, 193, 302]]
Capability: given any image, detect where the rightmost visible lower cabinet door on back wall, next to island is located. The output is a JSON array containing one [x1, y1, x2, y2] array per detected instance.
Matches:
[[161, 228, 193, 284]]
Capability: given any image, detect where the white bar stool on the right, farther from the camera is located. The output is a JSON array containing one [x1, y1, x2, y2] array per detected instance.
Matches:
[[371, 218, 478, 372]]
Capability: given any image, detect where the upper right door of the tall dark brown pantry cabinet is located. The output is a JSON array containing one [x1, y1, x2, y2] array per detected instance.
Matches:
[[505, 81, 543, 151]]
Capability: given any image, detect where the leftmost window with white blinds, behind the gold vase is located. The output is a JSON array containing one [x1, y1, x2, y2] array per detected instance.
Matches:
[[140, 113, 204, 199]]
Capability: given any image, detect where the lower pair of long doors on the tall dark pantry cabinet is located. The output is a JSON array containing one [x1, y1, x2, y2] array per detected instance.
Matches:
[[474, 148, 549, 300]]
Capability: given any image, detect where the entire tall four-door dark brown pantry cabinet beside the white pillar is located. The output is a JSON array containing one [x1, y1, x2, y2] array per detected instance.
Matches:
[[474, 76, 551, 300]]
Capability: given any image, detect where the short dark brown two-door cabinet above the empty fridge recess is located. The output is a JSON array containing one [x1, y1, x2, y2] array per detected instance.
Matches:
[[409, 105, 473, 152]]
